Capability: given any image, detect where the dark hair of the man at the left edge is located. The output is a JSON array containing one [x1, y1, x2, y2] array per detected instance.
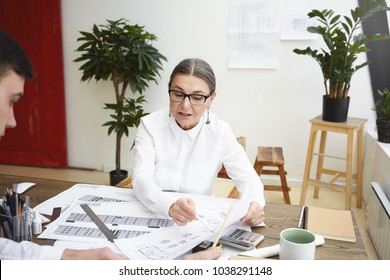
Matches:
[[0, 28, 34, 80]]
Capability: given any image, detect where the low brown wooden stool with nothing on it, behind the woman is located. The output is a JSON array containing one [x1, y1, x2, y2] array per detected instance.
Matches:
[[253, 147, 291, 204]]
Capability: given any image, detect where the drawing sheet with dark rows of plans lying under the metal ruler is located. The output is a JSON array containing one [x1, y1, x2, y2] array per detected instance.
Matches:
[[38, 201, 174, 243]]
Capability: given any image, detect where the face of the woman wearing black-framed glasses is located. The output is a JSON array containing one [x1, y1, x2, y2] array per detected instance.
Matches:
[[170, 74, 216, 130]]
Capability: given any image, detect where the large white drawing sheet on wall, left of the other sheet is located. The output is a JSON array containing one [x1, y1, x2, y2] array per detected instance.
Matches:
[[228, 0, 280, 69]]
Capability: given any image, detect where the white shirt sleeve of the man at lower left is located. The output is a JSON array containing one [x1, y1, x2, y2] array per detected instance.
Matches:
[[0, 238, 64, 260]]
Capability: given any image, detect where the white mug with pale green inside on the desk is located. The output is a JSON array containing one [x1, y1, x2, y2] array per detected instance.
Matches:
[[279, 228, 316, 260]]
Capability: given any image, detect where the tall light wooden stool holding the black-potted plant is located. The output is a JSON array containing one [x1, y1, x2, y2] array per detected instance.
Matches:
[[300, 115, 367, 210]]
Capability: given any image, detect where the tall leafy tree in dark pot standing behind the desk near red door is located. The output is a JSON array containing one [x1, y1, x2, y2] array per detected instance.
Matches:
[[74, 18, 166, 185]]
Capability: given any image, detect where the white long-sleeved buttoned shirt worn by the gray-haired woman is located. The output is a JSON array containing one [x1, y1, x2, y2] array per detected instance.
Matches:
[[132, 109, 265, 217]]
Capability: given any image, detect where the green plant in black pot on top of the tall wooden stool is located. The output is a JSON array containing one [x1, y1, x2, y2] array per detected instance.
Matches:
[[293, 0, 389, 122]]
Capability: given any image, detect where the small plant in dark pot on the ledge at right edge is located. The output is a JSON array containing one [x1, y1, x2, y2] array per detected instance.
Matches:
[[373, 88, 390, 143]]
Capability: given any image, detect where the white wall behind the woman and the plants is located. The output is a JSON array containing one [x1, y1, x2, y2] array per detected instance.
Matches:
[[62, 0, 375, 186]]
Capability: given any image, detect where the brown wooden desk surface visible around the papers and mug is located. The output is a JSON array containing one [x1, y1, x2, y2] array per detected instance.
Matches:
[[0, 174, 368, 260]]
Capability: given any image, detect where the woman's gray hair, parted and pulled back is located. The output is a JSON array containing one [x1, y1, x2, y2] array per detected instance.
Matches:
[[169, 58, 216, 93]]
